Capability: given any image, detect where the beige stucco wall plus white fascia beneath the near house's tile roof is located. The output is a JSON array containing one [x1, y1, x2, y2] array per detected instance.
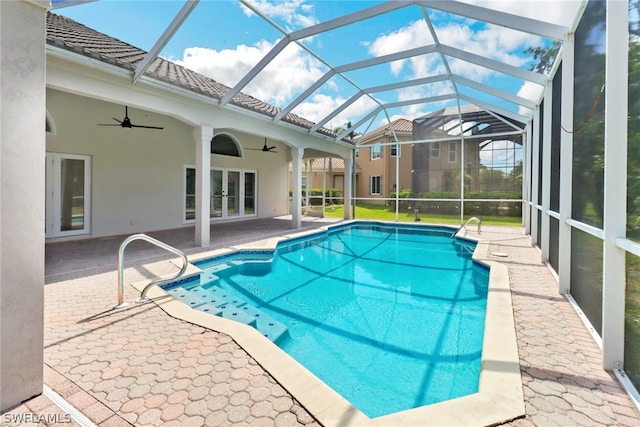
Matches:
[[46, 41, 352, 242]]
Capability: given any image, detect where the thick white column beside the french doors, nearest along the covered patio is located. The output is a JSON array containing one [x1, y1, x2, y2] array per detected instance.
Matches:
[[193, 126, 213, 247]]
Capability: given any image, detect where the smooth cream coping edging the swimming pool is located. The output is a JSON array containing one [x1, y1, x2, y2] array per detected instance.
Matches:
[[133, 221, 525, 427]]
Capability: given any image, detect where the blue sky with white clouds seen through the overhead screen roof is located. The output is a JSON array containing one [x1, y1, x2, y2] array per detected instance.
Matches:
[[54, 0, 579, 130]]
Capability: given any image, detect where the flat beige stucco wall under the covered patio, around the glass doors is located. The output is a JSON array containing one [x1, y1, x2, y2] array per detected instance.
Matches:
[[46, 89, 289, 237]]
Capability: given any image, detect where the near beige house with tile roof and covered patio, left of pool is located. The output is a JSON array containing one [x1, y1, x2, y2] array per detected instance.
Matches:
[[46, 13, 353, 246]]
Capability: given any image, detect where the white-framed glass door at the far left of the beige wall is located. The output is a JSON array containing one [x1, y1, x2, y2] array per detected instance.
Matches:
[[45, 153, 91, 238]]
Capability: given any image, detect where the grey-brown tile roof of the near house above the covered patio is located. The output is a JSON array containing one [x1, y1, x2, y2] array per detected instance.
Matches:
[[47, 13, 335, 137]]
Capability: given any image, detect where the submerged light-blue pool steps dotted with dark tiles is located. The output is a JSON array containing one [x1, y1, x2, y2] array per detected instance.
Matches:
[[168, 286, 288, 344]]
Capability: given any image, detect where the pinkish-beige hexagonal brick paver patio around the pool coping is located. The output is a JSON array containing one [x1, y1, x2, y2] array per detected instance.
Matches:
[[2, 220, 640, 426]]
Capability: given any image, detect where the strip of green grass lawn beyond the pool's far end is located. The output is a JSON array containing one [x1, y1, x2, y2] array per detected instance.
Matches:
[[316, 203, 522, 226]]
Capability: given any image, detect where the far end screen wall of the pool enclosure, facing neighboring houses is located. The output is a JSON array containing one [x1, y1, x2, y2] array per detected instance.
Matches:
[[344, 105, 524, 222]]
